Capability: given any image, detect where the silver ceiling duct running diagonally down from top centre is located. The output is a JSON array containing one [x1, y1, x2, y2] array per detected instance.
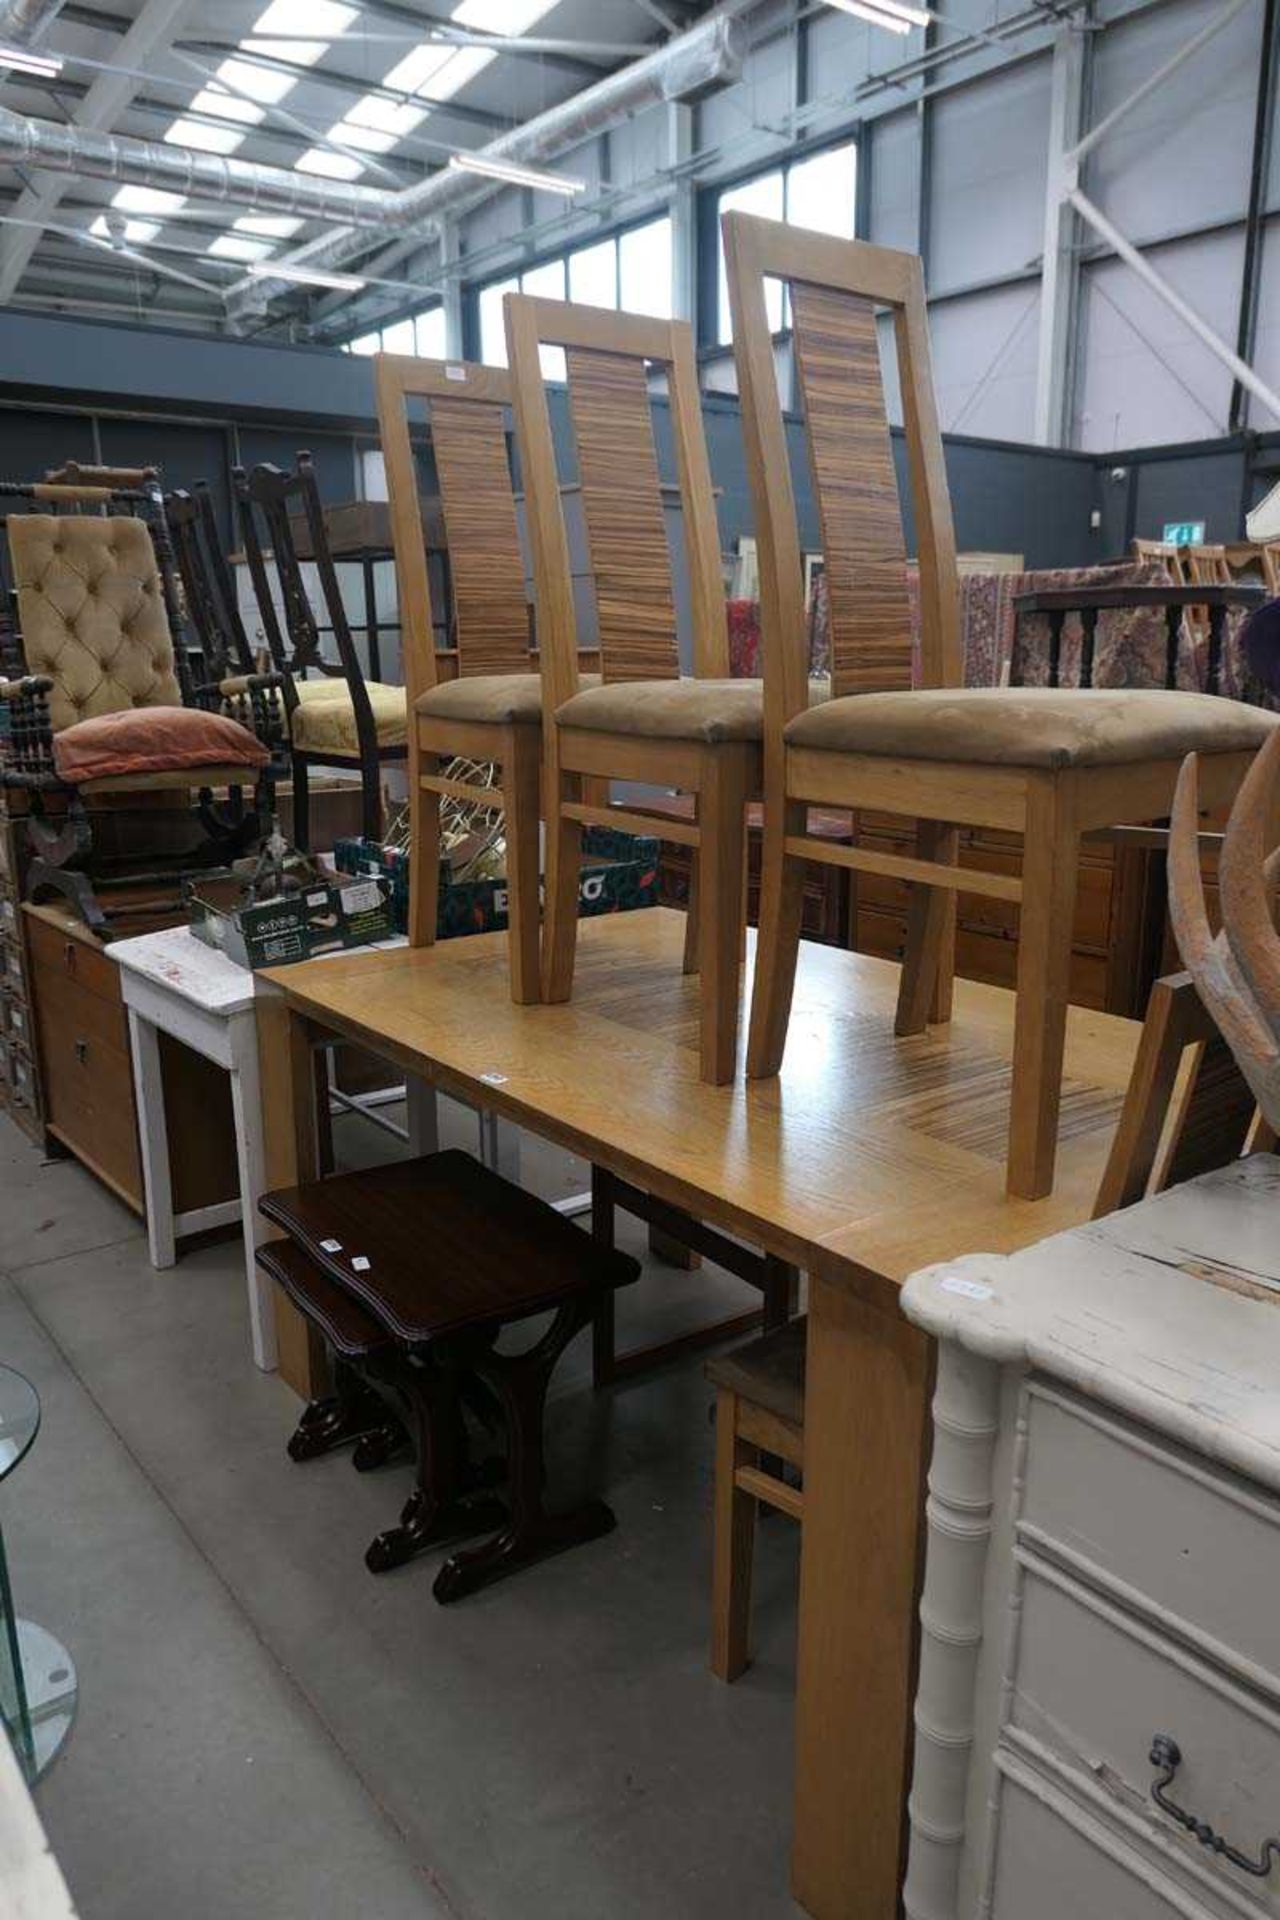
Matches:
[[228, 0, 756, 317]]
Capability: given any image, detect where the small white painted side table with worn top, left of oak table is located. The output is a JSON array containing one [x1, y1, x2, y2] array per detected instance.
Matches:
[[106, 927, 276, 1371]]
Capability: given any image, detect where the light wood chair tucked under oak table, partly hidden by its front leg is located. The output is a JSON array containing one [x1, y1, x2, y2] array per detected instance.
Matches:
[[706, 1315, 806, 1680]]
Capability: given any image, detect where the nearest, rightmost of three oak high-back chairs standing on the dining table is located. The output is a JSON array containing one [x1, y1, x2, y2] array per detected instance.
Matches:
[[723, 213, 1276, 1198]]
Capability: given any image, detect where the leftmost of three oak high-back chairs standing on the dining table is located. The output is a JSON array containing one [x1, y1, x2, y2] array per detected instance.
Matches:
[[374, 353, 543, 1002]]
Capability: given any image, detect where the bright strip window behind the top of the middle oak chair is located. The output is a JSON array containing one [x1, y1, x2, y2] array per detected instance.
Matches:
[[476, 215, 674, 380]]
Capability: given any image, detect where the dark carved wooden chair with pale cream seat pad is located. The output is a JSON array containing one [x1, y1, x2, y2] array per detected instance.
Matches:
[[232, 453, 409, 852]]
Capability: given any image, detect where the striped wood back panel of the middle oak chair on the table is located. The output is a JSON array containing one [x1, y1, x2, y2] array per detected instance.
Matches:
[[564, 348, 679, 680]]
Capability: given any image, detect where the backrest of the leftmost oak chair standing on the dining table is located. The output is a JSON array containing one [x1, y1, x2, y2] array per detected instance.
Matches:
[[374, 353, 532, 705]]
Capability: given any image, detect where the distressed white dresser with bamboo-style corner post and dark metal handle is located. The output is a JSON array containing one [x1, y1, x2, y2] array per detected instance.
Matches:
[[902, 1154, 1280, 1920]]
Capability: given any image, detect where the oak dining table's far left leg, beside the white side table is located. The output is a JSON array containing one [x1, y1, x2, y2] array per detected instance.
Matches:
[[253, 983, 328, 1400]]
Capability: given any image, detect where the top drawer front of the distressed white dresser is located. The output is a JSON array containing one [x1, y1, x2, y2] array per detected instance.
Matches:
[[1019, 1382, 1280, 1697]]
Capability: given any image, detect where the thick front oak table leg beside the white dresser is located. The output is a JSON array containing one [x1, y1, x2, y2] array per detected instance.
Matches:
[[791, 1273, 933, 1920]]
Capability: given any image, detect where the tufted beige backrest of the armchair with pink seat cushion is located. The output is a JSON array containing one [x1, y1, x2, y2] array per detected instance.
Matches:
[[8, 513, 182, 733]]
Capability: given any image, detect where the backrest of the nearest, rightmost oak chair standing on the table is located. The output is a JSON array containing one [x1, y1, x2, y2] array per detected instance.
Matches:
[[722, 213, 963, 737]]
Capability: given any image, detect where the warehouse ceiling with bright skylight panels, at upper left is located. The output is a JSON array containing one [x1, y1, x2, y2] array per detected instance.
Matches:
[[0, 0, 706, 334]]
